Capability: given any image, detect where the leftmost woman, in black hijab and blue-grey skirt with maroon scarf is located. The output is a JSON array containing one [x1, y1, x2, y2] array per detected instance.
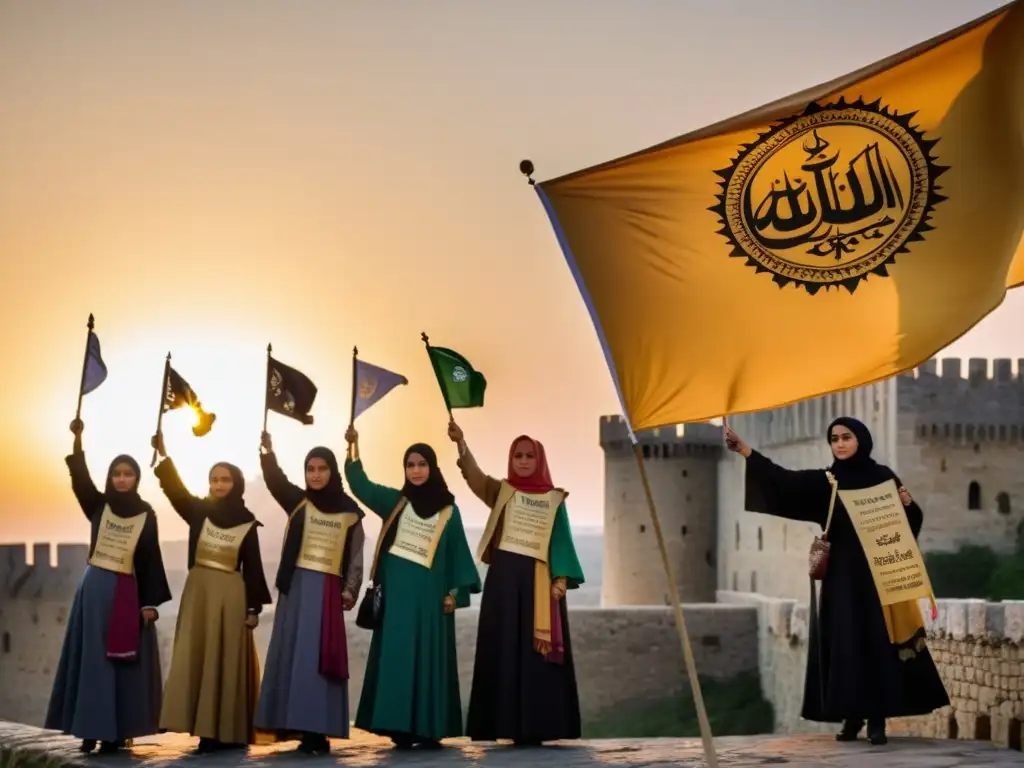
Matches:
[[45, 419, 171, 754]]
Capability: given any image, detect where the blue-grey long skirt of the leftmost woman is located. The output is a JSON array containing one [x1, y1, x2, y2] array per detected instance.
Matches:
[[45, 565, 163, 741]]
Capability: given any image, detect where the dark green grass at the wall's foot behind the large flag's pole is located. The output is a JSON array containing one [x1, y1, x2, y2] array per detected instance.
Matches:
[[583, 672, 775, 738]]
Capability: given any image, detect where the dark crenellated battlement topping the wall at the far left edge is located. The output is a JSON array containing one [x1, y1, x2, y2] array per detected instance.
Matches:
[[0, 544, 89, 603]]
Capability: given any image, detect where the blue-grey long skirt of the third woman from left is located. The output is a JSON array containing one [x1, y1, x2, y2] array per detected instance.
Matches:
[[256, 568, 349, 739]]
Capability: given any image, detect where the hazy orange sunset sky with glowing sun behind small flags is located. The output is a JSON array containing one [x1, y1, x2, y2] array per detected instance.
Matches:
[[0, 0, 1024, 542]]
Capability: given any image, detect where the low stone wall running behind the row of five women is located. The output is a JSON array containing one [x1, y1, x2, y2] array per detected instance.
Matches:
[[0, 544, 758, 726]]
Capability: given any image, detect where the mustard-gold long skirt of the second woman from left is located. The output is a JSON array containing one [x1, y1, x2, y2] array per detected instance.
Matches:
[[160, 566, 259, 744]]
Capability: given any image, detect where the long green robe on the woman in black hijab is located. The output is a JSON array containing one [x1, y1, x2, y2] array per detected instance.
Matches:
[[345, 460, 480, 740]]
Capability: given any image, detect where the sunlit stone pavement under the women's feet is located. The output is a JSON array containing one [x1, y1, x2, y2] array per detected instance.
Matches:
[[0, 722, 1024, 768]]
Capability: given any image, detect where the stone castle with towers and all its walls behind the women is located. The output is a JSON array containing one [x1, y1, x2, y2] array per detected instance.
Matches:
[[6, 358, 1024, 744]]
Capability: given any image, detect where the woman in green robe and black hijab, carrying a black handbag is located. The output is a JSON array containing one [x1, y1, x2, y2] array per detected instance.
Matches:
[[345, 426, 480, 749]]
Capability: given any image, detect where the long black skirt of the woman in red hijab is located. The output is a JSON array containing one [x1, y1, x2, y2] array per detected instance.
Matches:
[[466, 549, 581, 743]]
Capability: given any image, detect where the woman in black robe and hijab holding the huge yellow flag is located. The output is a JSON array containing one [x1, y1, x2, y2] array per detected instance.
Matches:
[[725, 417, 949, 744]]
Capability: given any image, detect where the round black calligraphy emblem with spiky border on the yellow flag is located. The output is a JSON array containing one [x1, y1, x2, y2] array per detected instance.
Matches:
[[709, 98, 947, 296]]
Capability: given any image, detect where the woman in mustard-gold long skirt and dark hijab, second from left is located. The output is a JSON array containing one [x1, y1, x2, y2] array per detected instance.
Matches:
[[153, 434, 270, 752]]
